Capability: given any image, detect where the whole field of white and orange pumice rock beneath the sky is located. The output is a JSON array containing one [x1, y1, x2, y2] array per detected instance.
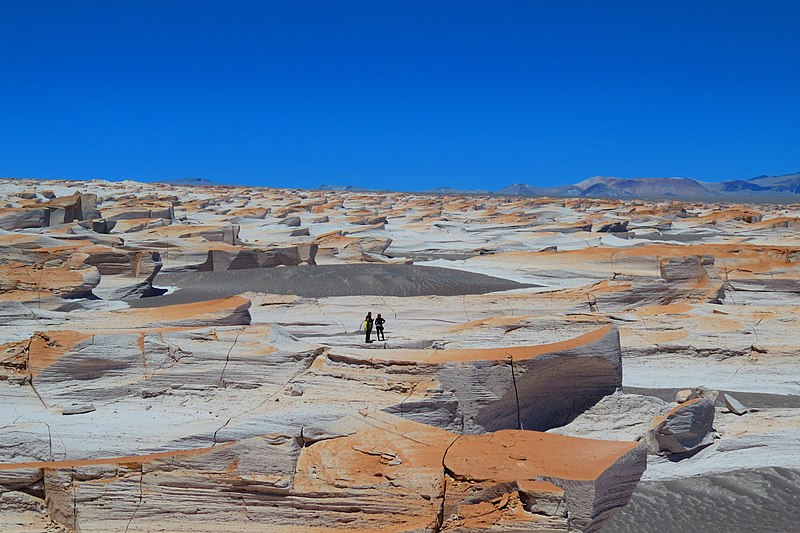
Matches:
[[0, 180, 800, 532]]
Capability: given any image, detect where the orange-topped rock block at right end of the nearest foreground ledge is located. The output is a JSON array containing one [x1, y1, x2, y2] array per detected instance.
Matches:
[[442, 430, 646, 532]]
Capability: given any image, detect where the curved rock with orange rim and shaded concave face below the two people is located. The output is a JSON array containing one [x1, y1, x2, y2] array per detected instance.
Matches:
[[366, 326, 622, 434]]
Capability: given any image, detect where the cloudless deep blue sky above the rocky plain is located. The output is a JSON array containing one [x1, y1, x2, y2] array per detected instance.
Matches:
[[0, 0, 800, 190]]
